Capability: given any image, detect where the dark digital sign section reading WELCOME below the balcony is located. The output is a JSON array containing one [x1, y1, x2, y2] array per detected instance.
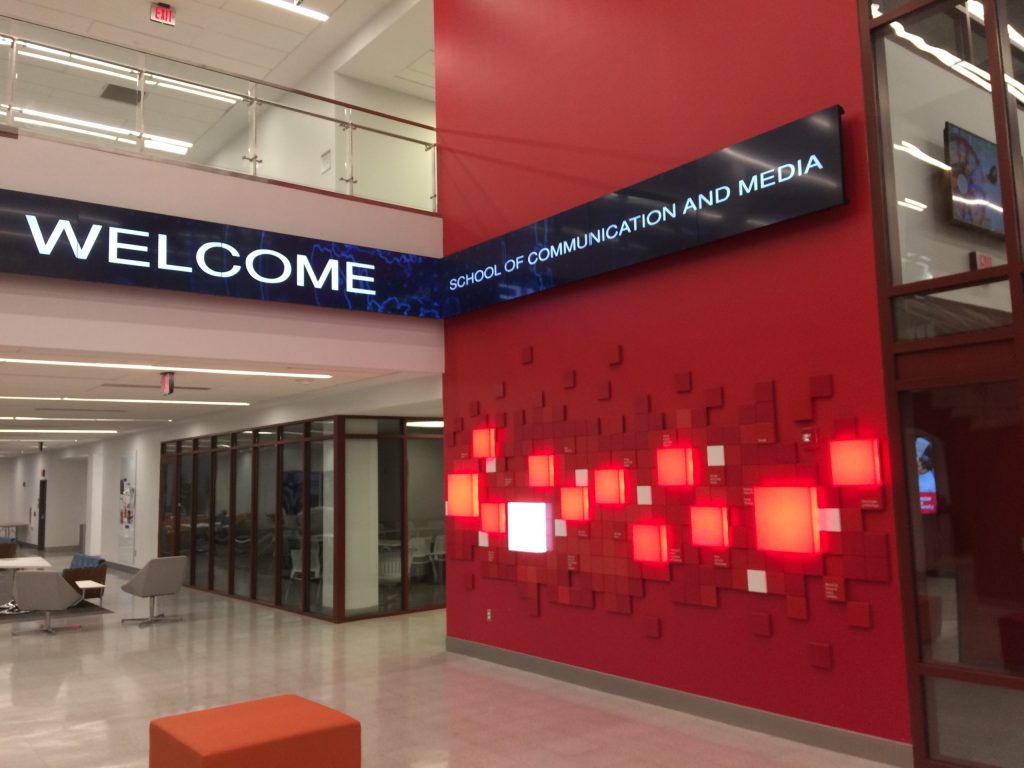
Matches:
[[0, 190, 440, 317]]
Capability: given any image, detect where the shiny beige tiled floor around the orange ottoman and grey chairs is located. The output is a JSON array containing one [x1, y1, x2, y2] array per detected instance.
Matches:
[[0, 558, 897, 768]]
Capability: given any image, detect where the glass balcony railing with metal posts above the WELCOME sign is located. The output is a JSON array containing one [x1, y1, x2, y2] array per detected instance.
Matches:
[[0, 16, 437, 211]]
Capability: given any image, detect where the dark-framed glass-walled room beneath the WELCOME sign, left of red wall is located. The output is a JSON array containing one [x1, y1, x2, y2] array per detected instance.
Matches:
[[159, 417, 444, 621]]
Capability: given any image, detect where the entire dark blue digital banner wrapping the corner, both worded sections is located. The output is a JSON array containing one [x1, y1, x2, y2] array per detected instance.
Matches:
[[0, 106, 846, 318]]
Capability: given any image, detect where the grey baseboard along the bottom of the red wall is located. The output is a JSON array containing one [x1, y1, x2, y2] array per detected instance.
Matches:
[[445, 637, 913, 768]]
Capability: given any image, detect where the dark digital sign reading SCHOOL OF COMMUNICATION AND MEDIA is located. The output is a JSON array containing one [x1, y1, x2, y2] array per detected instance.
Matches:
[[442, 106, 846, 314]]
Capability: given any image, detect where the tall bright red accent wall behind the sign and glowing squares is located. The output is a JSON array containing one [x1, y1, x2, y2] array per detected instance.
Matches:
[[435, 0, 910, 741]]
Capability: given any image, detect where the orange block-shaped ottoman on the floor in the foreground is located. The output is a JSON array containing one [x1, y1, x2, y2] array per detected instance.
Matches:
[[150, 694, 360, 768]]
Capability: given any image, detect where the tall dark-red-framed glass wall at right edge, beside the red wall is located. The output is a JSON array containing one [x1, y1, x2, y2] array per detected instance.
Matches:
[[862, 0, 1024, 768]]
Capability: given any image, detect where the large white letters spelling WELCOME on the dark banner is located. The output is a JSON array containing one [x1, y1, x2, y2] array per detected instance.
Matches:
[[25, 214, 378, 296]]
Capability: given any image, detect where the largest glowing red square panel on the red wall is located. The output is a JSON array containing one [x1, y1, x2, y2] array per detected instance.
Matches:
[[754, 486, 821, 553]]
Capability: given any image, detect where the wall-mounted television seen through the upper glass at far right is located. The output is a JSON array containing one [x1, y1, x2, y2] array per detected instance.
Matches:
[[945, 123, 1005, 234]]
